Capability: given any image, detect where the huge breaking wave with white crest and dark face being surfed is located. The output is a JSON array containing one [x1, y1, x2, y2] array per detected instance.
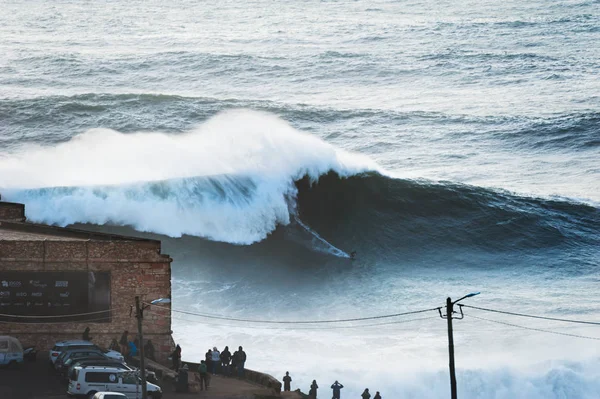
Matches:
[[0, 110, 600, 256]]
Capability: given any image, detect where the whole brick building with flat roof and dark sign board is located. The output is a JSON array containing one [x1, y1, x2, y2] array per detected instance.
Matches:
[[0, 202, 173, 360]]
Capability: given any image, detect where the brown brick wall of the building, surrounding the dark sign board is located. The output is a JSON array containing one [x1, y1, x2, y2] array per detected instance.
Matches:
[[0, 240, 173, 361]]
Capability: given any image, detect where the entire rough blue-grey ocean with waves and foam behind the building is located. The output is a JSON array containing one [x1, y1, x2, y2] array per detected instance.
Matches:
[[0, 0, 600, 399]]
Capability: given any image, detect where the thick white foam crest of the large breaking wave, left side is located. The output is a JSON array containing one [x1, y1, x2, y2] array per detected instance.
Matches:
[[0, 110, 379, 244]]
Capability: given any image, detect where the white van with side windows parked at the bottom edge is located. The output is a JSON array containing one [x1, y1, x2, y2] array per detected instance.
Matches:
[[67, 366, 162, 399]]
